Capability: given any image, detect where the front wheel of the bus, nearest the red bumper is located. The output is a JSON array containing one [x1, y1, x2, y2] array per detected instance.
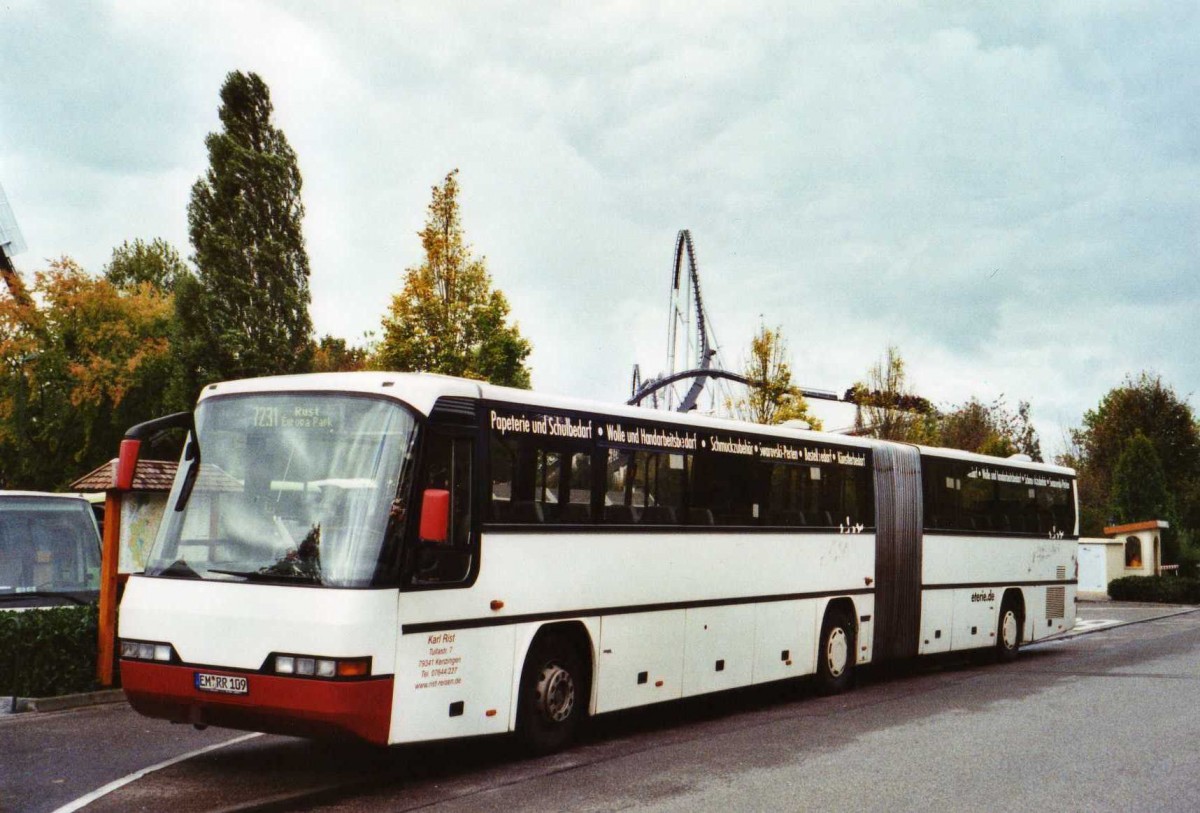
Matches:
[[517, 632, 588, 754]]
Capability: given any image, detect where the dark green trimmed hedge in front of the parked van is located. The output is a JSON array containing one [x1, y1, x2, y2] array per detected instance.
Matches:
[[0, 604, 100, 697]]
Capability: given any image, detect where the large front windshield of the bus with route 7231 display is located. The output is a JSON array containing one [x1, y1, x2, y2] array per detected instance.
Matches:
[[145, 393, 415, 588]]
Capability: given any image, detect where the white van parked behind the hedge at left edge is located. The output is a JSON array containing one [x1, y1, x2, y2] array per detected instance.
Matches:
[[0, 490, 100, 610]]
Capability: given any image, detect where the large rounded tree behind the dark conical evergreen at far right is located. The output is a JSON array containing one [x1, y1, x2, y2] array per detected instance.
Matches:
[[1063, 372, 1200, 535]]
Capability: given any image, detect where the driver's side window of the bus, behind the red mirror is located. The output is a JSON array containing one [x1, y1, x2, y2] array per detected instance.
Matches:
[[408, 433, 474, 585]]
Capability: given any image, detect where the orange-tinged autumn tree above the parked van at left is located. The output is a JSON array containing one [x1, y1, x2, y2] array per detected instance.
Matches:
[[0, 258, 172, 490]]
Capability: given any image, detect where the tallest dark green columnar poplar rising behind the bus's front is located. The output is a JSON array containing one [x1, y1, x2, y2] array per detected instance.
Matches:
[[176, 71, 312, 403]]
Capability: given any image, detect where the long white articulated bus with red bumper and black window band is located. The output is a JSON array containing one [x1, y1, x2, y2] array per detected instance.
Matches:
[[120, 373, 1078, 751]]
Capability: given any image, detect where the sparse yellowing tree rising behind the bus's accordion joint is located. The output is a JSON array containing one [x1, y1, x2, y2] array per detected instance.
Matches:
[[846, 345, 936, 442]]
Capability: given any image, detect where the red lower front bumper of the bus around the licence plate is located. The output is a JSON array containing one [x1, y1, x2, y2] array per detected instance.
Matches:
[[121, 658, 394, 745]]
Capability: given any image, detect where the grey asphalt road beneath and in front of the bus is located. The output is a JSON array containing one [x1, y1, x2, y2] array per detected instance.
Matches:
[[7, 604, 1200, 813]]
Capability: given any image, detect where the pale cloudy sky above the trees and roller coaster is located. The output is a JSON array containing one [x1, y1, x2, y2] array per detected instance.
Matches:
[[0, 0, 1200, 451]]
